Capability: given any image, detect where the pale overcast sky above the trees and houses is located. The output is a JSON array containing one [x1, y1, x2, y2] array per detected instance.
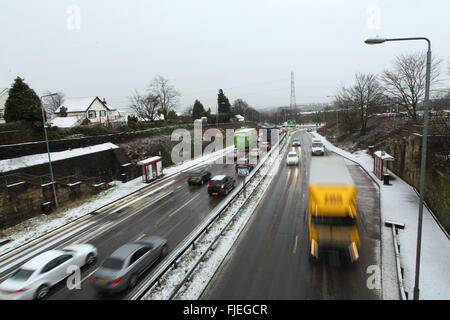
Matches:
[[0, 0, 450, 112]]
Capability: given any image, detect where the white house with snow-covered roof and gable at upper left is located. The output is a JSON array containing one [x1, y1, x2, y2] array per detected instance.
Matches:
[[51, 97, 120, 127]]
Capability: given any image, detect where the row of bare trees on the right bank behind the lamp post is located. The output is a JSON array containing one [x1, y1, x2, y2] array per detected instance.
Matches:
[[333, 52, 450, 133]]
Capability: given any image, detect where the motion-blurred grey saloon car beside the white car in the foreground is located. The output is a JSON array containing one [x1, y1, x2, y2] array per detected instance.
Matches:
[[91, 236, 168, 293]]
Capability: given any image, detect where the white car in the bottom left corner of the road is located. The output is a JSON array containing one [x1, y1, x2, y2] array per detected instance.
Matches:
[[0, 243, 97, 300]]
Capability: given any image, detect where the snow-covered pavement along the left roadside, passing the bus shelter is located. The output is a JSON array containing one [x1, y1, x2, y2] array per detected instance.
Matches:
[[0, 145, 233, 255]]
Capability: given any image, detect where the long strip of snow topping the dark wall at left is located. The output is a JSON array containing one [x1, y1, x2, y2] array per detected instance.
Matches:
[[0, 142, 119, 173]]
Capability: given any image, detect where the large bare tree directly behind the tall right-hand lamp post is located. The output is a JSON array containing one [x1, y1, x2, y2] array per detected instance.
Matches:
[[381, 52, 441, 119]]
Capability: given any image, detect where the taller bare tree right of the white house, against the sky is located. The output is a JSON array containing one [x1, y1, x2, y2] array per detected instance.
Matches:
[[149, 76, 180, 119]]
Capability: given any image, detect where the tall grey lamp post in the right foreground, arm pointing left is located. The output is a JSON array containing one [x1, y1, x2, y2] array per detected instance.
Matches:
[[364, 37, 431, 300]]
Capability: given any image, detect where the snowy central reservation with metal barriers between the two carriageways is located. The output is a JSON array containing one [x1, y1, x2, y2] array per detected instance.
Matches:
[[142, 132, 289, 300]]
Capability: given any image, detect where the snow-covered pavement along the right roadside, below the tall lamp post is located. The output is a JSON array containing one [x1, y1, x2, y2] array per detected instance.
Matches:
[[311, 132, 450, 300]]
